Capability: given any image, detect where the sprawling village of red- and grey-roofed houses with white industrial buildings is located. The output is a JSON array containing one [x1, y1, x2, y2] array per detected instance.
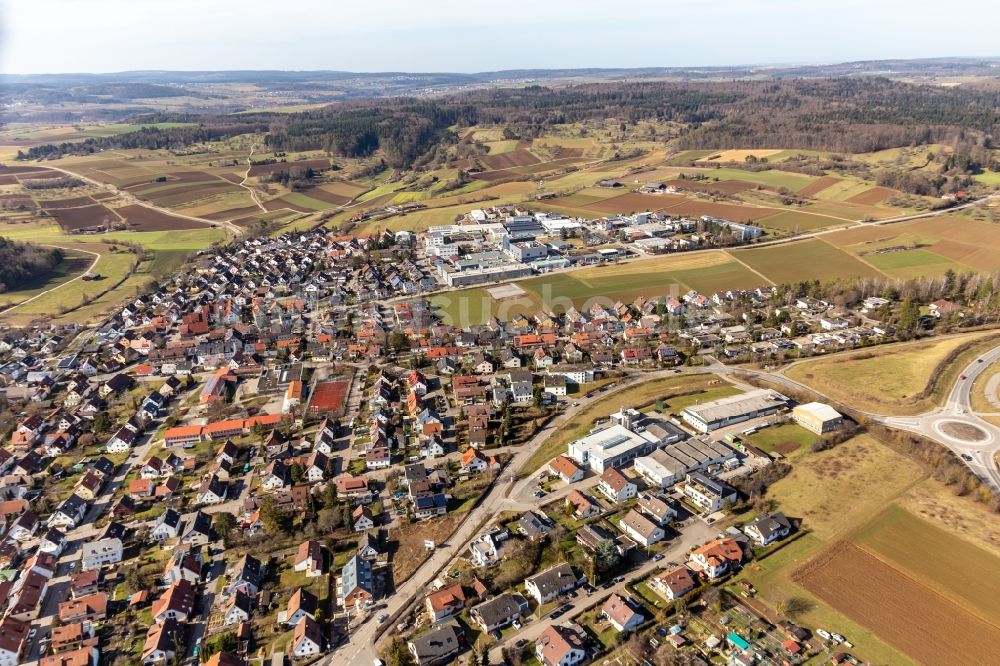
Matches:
[[0, 198, 984, 666]]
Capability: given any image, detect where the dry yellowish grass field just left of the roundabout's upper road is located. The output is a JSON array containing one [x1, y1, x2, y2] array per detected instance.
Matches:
[[785, 331, 996, 415]]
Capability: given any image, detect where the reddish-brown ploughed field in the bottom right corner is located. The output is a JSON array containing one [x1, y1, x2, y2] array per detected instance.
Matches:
[[793, 541, 1000, 664]]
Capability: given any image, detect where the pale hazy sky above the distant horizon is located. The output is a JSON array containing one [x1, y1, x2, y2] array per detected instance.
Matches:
[[0, 0, 1000, 73]]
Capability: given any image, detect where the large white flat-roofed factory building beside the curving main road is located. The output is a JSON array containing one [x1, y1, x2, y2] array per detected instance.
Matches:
[[567, 409, 677, 474]]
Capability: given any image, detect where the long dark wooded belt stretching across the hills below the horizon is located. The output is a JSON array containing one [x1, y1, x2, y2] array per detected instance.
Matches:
[[22, 77, 1000, 168]]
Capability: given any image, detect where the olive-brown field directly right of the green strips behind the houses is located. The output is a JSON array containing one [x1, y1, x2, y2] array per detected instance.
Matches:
[[730, 239, 879, 284]]
